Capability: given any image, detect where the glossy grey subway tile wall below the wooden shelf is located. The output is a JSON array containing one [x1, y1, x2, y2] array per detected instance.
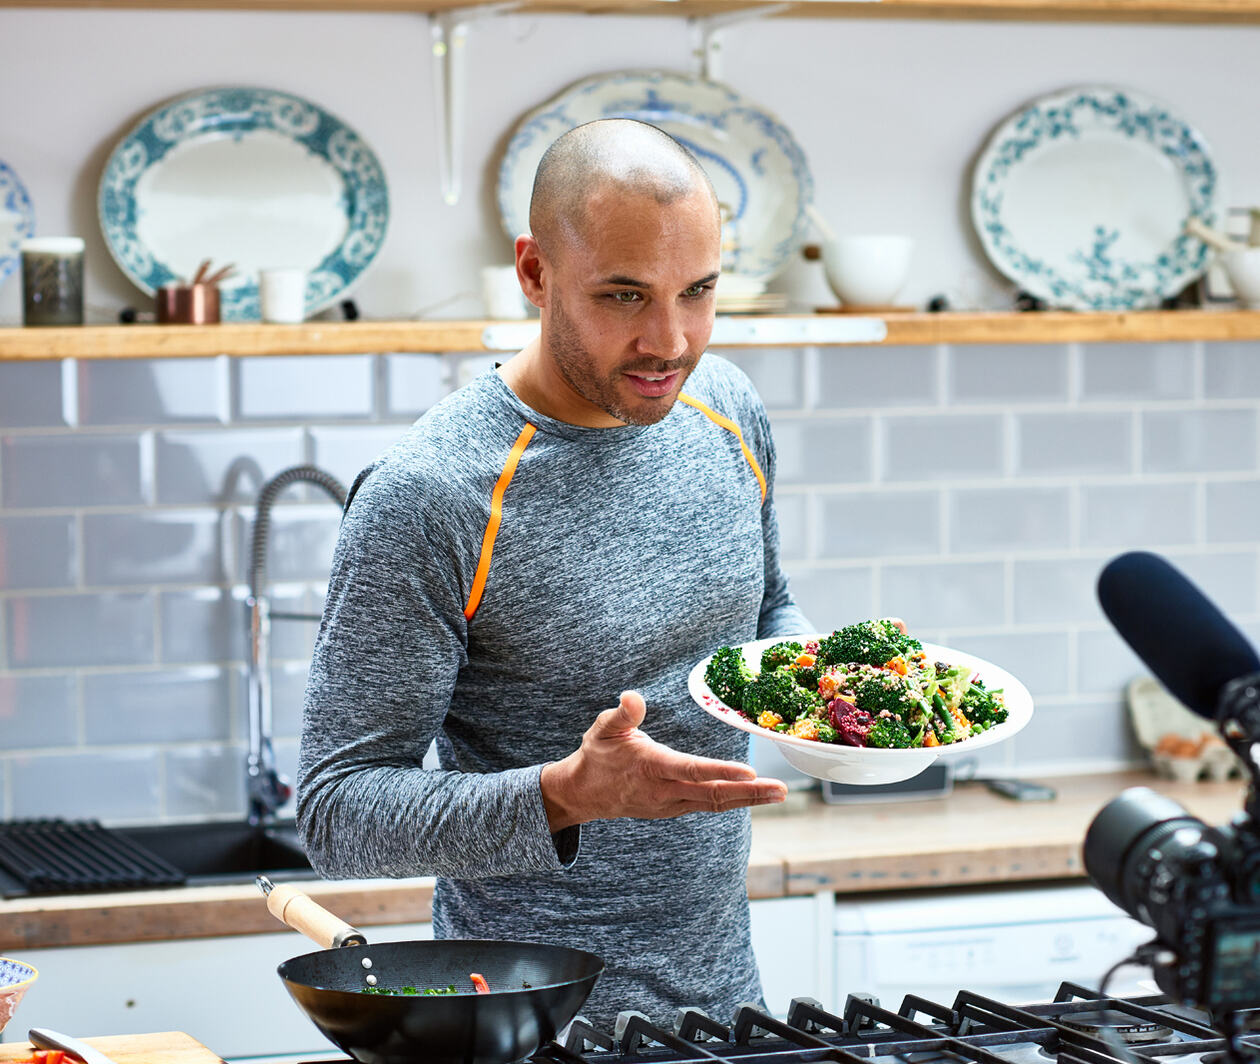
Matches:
[[0, 343, 1260, 823]]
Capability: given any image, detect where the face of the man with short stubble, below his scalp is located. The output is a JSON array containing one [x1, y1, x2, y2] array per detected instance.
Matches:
[[542, 189, 722, 427]]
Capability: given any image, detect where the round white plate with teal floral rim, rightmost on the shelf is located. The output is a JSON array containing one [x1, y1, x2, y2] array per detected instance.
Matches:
[[971, 86, 1221, 310]]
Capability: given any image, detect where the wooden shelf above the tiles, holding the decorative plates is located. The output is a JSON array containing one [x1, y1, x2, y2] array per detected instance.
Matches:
[[0, 310, 1260, 362]]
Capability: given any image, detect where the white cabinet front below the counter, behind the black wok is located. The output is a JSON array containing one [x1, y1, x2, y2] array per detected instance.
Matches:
[[7, 924, 433, 1058]]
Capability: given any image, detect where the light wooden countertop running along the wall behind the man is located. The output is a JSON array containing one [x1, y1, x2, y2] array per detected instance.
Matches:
[[0, 772, 1242, 953]]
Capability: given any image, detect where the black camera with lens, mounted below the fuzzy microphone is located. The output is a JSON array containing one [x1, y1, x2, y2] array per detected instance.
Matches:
[[1085, 787, 1260, 1015]]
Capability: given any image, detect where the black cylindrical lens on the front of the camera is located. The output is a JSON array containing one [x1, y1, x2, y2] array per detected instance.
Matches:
[[1085, 787, 1206, 943]]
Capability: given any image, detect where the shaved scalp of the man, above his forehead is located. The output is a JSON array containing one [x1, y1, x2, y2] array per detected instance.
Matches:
[[529, 119, 721, 255]]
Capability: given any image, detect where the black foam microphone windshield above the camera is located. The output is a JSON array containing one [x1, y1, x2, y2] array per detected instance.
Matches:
[[1099, 551, 1260, 721]]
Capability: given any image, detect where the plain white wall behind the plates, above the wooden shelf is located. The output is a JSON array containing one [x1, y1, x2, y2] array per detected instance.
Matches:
[[0, 9, 1260, 323]]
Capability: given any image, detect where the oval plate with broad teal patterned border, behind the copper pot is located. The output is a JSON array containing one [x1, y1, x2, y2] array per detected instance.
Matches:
[[98, 87, 389, 321]]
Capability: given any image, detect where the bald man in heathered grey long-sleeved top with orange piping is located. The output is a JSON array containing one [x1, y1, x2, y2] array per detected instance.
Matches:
[[297, 120, 809, 1025]]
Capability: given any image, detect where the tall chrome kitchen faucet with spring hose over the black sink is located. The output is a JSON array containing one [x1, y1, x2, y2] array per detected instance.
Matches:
[[246, 465, 345, 824]]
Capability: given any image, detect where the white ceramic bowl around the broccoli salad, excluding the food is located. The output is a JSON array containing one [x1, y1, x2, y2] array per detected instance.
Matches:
[[687, 633, 1032, 784]]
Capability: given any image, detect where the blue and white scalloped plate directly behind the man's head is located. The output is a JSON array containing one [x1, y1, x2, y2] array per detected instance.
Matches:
[[499, 71, 814, 280]]
